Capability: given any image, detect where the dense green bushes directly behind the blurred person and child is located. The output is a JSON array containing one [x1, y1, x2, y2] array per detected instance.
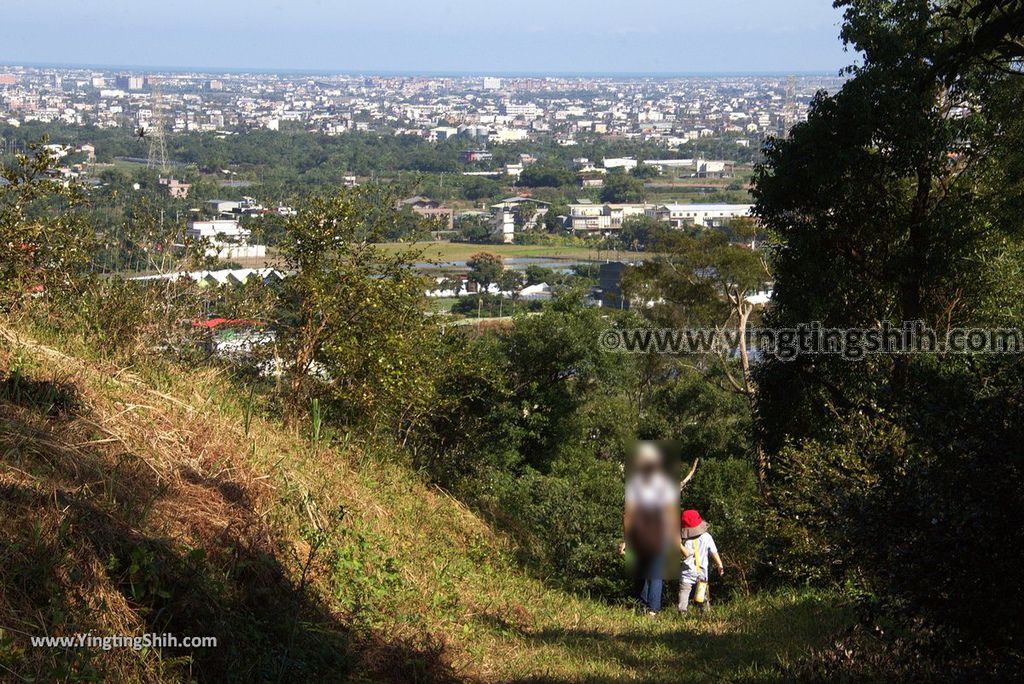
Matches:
[[414, 288, 763, 599]]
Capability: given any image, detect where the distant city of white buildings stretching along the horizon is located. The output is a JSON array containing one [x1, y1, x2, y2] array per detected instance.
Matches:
[[0, 67, 843, 148]]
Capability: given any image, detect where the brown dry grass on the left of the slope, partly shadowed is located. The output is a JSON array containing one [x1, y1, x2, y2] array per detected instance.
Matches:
[[0, 327, 428, 681]]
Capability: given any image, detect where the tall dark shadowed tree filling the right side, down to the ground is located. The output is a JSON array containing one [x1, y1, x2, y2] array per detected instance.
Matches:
[[754, 0, 1024, 667]]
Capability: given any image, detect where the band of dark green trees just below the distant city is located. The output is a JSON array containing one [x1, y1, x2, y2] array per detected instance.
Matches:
[[0, 122, 757, 202]]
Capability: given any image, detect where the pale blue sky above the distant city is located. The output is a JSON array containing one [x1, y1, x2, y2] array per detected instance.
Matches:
[[0, 0, 853, 74]]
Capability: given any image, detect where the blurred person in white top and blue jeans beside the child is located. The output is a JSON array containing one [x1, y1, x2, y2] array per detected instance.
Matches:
[[620, 442, 679, 615]]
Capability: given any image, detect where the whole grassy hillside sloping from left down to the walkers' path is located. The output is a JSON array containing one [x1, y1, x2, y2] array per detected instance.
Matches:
[[0, 331, 849, 681]]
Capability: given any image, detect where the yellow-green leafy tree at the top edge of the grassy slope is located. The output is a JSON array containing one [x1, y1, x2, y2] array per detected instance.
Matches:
[[274, 186, 432, 432]]
